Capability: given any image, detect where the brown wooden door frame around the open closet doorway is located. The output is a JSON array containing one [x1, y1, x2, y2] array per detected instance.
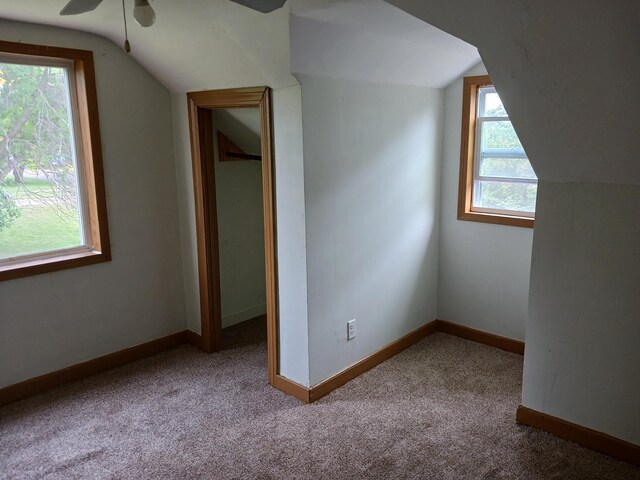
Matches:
[[187, 87, 278, 384]]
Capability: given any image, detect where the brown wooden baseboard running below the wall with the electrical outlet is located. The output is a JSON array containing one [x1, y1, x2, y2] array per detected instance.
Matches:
[[309, 321, 437, 402]]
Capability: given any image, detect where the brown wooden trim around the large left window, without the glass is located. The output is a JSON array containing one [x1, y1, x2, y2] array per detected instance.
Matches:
[[0, 40, 111, 281]]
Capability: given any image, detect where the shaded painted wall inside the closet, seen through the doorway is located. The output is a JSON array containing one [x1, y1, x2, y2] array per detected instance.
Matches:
[[213, 108, 267, 327]]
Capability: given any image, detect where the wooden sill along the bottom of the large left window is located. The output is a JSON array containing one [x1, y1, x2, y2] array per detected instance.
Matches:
[[0, 251, 111, 281]]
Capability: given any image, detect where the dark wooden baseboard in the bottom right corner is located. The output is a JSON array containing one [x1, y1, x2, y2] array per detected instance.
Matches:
[[516, 405, 640, 466]]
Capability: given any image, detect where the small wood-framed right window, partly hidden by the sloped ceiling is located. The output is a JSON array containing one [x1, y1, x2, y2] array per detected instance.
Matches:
[[458, 75, 538, 227]]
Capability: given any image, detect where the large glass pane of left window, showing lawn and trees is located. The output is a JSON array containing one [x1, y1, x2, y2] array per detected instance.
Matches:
[[0, 63, 84, 260]]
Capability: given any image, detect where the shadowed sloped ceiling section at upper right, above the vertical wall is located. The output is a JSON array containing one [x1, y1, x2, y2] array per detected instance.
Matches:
[[387, 0, 640, 185]]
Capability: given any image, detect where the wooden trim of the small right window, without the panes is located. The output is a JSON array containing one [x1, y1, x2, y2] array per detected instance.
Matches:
[[458, 75, 534, 228]]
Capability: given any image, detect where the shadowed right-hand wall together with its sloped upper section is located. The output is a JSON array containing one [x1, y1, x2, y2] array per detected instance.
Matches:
[[388, 0, 640, 444]]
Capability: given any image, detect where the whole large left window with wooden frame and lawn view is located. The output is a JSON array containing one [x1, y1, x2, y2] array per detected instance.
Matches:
[[0, 41, 111, 280]]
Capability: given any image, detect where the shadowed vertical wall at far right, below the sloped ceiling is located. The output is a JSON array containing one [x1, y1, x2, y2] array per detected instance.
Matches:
[[522, 182, 640, 445]]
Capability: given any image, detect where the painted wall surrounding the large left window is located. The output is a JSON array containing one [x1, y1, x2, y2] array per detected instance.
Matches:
[[0, 20, 185, 386]]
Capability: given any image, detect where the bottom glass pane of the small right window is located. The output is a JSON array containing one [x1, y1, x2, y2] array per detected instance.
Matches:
[[473, 181, 538, 212]]
